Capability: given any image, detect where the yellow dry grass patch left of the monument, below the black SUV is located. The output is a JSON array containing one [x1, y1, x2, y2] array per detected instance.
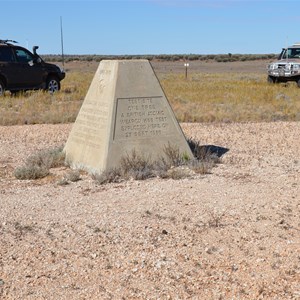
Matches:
[[0, 72, 93, 125]]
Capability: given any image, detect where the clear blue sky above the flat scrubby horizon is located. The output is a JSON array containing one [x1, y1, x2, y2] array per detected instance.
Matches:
[[0, 0, 300, 55]]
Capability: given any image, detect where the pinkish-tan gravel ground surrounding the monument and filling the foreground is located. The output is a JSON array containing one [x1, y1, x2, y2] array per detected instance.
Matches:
[[0, 122, 300, 300]]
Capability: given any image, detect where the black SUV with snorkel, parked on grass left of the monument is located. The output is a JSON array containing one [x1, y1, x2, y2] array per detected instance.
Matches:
[[0, 40, 65, 96]]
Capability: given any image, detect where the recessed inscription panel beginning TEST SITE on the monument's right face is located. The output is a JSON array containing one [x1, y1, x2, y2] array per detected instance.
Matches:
[[114, 96, 172, 140]]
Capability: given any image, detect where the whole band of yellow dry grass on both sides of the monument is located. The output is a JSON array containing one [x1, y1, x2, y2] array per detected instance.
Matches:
[[0, 63, 300, 125]]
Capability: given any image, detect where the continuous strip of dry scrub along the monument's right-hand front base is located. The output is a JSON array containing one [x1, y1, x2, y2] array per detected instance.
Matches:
[[93, 139, 220, 184]]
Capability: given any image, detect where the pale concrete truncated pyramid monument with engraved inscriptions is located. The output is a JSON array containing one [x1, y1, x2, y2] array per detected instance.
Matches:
[[64, 60, 193, 173]]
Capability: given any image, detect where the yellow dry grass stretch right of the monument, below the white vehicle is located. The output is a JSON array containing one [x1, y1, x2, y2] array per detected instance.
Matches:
[[160, 73, 300, 122]]
